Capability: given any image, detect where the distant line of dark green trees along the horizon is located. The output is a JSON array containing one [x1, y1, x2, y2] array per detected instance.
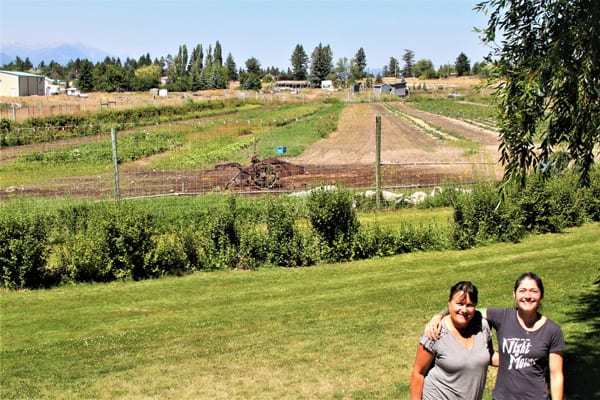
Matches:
[[2, 41, 485, 92]]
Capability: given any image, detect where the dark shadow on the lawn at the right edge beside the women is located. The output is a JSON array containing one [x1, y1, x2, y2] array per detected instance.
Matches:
[[564, 281, 600, 400]]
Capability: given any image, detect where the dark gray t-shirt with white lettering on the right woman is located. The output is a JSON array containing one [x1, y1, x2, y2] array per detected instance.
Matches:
[[486, 308, 565, 400]]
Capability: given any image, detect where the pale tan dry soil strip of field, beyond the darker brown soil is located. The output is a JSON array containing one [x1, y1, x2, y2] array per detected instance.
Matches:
[[291, 103, 499, 165]]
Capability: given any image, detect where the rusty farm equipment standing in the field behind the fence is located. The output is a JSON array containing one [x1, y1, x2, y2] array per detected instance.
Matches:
[[215, 154, 304, 190]]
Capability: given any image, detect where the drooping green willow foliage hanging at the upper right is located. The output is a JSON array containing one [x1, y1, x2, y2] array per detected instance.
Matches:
[[475, 0, 600, 186]]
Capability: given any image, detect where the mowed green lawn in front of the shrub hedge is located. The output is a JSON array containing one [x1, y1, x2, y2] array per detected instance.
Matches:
[[0, 223, 600, 399]]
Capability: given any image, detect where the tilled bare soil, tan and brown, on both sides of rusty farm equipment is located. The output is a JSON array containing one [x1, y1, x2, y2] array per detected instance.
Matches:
[[0, 103, 502, 198]]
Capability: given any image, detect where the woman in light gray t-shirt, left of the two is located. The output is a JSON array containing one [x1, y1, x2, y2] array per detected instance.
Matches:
[[410, 282, 493, 400]]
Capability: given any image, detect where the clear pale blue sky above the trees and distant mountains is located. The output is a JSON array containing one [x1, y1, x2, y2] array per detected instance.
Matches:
[[0, 0, 487, 69]]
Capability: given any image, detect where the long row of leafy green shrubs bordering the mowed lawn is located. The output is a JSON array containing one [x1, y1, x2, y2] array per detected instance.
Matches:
[[0, 169, 600, 289]]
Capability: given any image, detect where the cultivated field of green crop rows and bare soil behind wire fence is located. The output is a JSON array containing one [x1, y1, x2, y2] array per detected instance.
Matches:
[[0, 92, 503, 206]]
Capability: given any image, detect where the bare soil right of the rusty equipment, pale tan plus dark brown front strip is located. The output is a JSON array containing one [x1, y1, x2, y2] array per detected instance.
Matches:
[[290, 103, 502, 192]]
